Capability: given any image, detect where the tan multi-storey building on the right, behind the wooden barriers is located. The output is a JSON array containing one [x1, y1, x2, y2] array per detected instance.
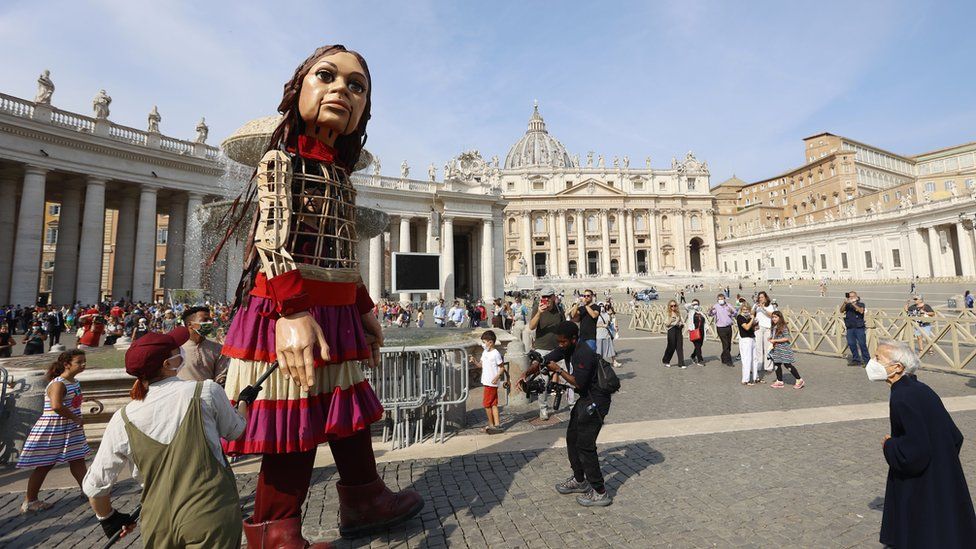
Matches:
[[713, 133, 976, 279]]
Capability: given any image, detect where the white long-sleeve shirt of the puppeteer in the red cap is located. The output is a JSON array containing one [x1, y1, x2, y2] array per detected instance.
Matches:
[[82, 377, 246, 497]]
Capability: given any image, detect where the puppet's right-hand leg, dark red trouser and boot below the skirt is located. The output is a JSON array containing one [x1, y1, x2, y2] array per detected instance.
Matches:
[[329, 430, 424, 538]]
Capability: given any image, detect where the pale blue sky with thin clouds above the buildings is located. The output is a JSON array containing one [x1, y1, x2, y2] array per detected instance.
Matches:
[[0, 0, 976, 185]]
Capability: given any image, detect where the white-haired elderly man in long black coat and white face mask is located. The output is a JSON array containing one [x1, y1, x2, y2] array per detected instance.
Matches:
[[865, 339, 976, 549]]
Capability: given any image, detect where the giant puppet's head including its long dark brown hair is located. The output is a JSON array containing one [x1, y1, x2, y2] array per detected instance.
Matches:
[[268, 45, 372, 170]]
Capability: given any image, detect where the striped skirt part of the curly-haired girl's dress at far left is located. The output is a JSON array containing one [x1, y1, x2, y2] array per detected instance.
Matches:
[[17, 412, 91, 469]]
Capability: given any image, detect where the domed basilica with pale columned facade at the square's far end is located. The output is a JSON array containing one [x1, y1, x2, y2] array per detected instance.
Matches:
[[445, 105, 718, 285]]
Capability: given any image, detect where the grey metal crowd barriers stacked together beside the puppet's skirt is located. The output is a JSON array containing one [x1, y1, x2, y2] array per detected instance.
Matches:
[[363, 346, 469, 450]]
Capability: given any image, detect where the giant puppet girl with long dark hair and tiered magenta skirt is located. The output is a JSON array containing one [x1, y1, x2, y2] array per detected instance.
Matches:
[[216, 46, 423, 548]]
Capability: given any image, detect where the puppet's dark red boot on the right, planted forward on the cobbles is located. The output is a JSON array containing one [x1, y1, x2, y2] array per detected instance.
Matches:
[[336, 478, 424, 538]]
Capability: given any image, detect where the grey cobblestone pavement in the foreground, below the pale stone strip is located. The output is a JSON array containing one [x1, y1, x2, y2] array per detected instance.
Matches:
[[0, 412, 976, 548]]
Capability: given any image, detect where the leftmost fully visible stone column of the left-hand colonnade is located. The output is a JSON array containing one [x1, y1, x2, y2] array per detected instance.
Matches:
[[7, 166, 47, 305]]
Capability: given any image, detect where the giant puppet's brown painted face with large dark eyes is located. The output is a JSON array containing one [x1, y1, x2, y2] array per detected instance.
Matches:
[[298, 52, 369, 145]]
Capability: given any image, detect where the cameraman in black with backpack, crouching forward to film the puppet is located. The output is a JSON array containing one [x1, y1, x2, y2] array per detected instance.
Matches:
[[518, 322, 613, 507]]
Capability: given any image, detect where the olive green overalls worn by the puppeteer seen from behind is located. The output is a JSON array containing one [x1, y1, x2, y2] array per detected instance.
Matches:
[[122, 382, 241, 549]]
